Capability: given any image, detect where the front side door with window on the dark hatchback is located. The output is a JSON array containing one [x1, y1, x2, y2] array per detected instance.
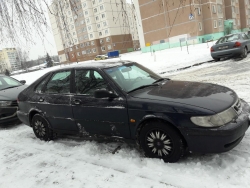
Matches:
[[72, 69, 130, 138]]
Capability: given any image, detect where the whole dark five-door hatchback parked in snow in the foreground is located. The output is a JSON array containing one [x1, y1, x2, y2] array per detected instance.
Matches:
[[18, 61, 250, 162]]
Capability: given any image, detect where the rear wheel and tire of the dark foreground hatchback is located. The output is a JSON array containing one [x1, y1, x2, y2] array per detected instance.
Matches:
[[31, 114, 55, 141]]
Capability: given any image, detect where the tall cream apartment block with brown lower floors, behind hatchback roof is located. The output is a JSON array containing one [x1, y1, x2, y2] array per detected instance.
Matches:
[[49, 0, 139, 62]]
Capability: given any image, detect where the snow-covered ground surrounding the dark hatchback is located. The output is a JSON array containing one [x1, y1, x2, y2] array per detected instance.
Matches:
[[0, 46, 250, 188]]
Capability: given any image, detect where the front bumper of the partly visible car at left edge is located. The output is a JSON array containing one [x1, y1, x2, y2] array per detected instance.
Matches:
[[0, 107, 20, 126]]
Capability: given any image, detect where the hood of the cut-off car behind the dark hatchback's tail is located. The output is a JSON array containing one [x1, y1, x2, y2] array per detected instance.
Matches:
[[0, 85, 28, 101]]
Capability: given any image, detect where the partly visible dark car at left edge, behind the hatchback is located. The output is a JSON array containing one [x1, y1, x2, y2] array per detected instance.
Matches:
[[0, 74, 27, 126]]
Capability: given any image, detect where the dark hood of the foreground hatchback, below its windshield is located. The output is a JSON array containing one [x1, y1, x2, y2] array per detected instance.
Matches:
[[131, 80, 238, 113]]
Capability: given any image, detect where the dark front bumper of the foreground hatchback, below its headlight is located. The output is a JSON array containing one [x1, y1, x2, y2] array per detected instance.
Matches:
[[181, 100, 250, 153]]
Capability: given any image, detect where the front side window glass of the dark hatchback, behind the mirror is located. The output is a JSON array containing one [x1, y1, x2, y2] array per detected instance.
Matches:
[[75, 69, 107, 96]]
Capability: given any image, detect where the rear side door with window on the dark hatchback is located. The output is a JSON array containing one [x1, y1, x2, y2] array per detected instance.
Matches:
[[35, 70, 78, 132]]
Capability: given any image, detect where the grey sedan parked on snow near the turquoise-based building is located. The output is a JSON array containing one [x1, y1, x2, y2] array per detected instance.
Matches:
[[211, 33, 250, 61]]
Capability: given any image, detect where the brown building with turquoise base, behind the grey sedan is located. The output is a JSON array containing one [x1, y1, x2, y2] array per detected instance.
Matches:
[[134, 0, 250, 52]]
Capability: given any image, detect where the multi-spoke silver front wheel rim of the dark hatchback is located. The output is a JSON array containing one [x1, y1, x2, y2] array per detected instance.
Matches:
[[146, 130, 173, 157]]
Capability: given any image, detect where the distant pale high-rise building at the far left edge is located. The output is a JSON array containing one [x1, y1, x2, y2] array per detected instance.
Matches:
[[0, 48, 21, 73]]
